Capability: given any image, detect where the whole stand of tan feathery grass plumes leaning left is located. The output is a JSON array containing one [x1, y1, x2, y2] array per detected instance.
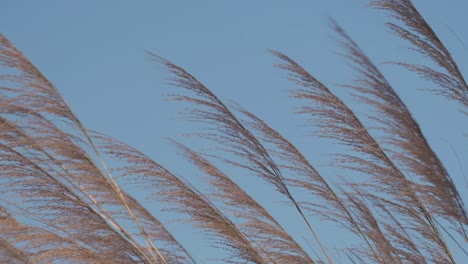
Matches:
[[0, 0, 468, 264]]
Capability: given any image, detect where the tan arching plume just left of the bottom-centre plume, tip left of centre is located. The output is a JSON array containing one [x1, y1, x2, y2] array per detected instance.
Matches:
[[95, 135, 266, 263]]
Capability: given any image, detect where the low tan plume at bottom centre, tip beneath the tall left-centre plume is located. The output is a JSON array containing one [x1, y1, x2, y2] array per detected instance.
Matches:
[[173, 141, 314, 263]]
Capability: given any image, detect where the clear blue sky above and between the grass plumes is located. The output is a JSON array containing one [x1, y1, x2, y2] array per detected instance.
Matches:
[[0, 0, 468, 262]]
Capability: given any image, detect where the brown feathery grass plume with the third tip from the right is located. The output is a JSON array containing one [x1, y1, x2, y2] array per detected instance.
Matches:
[[274, 52, 454, 263]]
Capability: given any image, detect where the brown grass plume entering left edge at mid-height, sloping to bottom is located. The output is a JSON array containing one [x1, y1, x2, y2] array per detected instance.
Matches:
[[0, 144, 144, 263]]
